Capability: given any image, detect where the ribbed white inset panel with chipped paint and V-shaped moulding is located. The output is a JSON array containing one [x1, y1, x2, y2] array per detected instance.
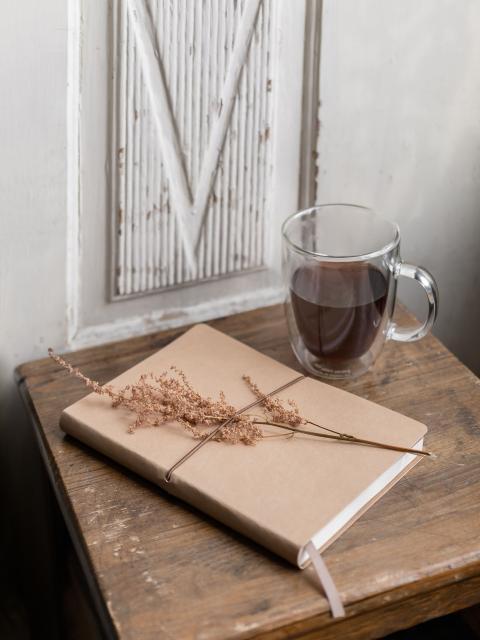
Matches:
[[113, 0, 275, 297]]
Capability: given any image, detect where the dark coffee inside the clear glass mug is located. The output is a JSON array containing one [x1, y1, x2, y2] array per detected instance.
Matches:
[[290, 263, 388, 365]]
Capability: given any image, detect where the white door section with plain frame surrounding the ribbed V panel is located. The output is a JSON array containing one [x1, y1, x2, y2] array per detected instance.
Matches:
[[76, 0, 305, 345]]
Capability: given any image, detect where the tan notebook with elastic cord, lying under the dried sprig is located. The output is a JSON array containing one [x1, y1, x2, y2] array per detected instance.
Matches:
[[60, 324, 427, 616]]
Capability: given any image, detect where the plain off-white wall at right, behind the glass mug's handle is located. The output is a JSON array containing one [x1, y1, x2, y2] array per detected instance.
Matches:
[[317, 0, 480, 373]]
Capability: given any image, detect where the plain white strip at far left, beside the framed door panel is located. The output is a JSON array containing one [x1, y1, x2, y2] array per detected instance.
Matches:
[[0, 0, 67, 413]]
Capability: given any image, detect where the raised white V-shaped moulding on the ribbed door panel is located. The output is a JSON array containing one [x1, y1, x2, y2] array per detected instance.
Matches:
[[128, 0, 262, 275]]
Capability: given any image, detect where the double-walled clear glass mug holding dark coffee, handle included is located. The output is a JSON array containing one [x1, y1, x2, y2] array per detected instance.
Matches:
[[282, 204, 438, 378]]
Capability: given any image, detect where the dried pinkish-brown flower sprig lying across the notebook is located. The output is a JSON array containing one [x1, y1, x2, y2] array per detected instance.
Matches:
[[48, 349, 434, 457]]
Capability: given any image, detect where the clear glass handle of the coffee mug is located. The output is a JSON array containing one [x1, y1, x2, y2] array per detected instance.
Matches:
[[387, 262, 438, 342]]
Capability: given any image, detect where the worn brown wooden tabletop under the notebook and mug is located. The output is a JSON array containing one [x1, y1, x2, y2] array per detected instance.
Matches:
[[17, 306, 480, 640]]
